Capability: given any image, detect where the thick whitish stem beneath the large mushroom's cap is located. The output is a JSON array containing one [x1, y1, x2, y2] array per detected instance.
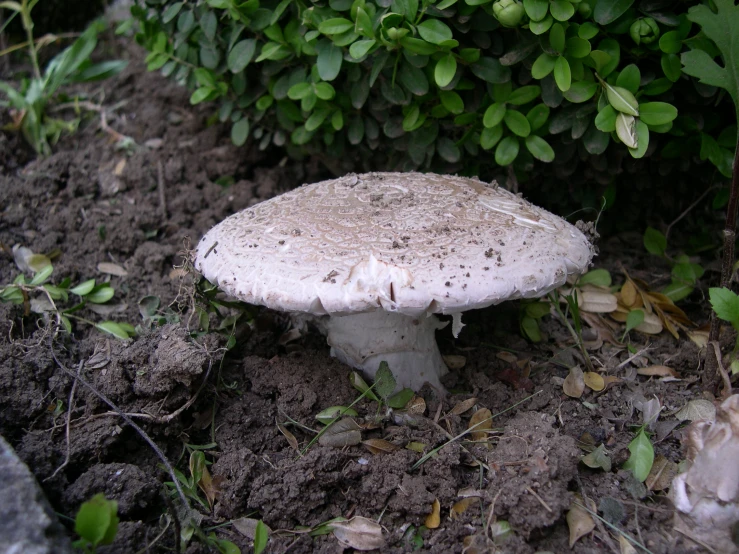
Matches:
[[326, 310, 448, 391]]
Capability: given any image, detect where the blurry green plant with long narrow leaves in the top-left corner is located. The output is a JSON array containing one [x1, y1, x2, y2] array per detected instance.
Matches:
[[0, 0, 127, 156]]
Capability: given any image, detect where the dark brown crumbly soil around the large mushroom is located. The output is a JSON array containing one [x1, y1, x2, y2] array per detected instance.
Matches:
[[0, 34, 728, 553]]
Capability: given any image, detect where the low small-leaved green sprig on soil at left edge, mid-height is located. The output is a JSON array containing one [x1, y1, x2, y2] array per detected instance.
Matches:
[[0, 255, 136, 340]]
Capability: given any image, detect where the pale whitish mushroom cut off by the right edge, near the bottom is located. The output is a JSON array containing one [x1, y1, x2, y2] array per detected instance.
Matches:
[[670, 394, 739, 553]]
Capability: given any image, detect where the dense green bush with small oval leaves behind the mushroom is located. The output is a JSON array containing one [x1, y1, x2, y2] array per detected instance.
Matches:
[[132, 0, 736, 194]]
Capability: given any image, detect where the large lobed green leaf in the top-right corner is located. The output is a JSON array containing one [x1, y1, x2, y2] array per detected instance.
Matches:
[[684, 0, 739, 107]]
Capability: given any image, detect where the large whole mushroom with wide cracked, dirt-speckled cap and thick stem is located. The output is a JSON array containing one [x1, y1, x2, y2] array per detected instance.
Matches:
[[195, 173, 593, 390]]
